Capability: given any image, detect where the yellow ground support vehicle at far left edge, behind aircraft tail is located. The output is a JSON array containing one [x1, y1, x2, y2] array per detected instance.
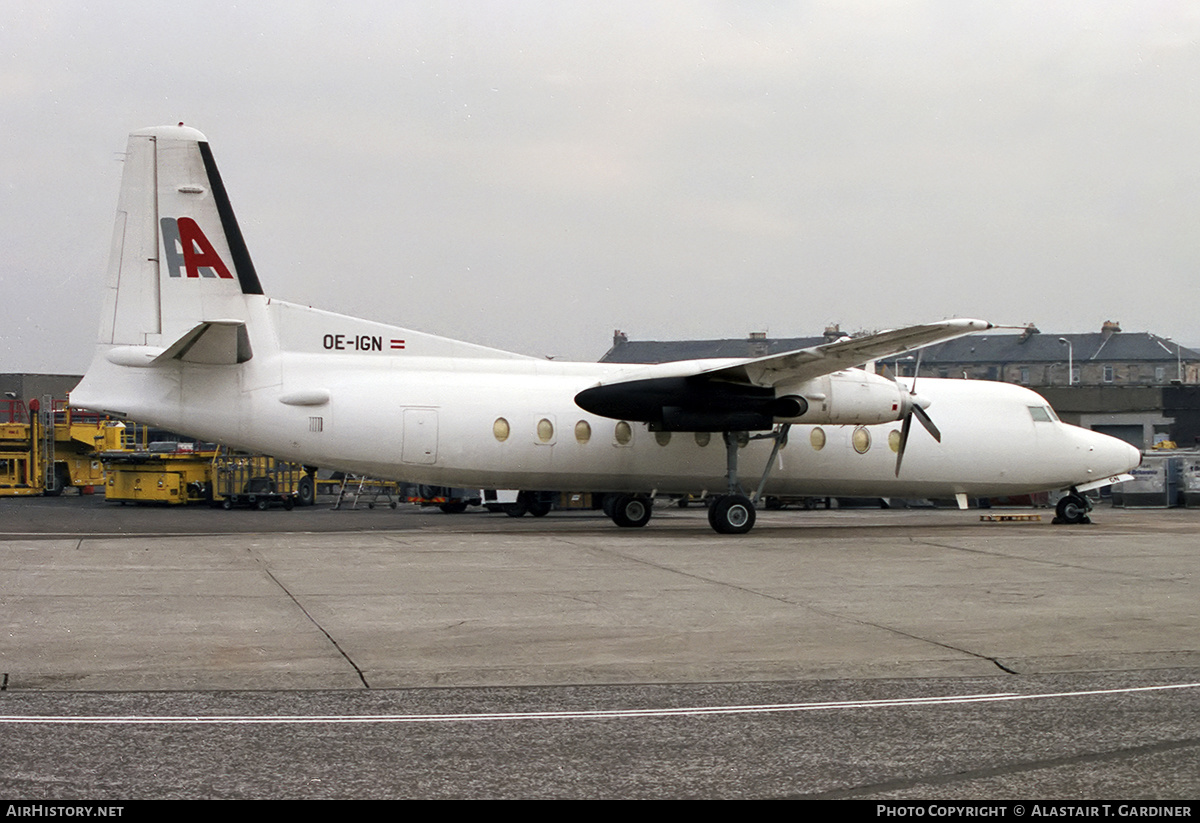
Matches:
[[0, 397, 125, 495]]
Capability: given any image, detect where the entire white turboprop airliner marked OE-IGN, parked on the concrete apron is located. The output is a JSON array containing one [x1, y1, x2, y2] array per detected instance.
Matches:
[[71, 126, 1140, 534]]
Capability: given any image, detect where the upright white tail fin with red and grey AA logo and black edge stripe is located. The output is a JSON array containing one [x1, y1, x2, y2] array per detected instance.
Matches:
[[100, 125, 263, 348]]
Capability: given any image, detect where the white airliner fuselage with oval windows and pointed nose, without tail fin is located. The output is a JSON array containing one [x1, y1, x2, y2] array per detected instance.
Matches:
[[88, 321, 1136, 497]]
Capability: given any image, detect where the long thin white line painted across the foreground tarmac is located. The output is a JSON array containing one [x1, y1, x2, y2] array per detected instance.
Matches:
[[0, 683, 1200, 726]]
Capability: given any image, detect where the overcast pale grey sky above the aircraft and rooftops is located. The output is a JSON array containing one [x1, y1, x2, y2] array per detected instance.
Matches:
[[0, 0, 1200, 372]]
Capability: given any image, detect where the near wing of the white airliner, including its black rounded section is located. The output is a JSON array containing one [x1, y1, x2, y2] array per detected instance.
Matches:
[[575, 319, 992, 431]]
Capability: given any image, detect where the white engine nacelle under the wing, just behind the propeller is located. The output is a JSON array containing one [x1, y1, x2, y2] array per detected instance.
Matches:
[[775, 368, 912, 426]]
